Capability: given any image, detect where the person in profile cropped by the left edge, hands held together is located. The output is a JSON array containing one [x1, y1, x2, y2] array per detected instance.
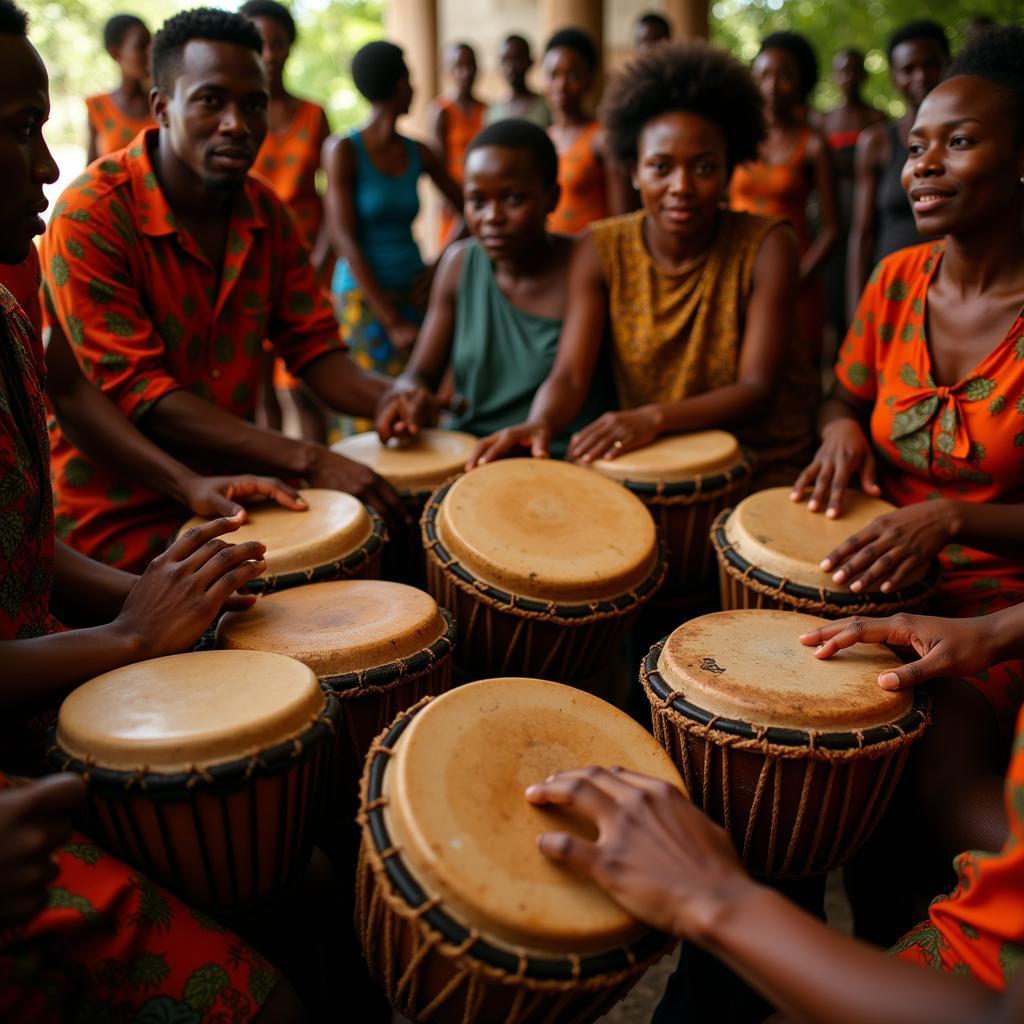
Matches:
[[0, 6, 302, 1024]]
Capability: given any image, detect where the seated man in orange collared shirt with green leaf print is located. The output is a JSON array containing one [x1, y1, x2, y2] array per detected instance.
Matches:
[[43, 9, 403, 569]]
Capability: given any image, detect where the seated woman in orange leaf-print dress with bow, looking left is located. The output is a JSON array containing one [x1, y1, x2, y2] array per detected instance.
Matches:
[[793, 28, 1024, 746]]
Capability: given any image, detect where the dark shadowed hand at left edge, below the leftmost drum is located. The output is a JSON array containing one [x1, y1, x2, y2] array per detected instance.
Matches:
[[0, 774, 85, 932]]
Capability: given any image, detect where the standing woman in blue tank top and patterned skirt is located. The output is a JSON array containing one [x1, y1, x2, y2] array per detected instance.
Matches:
[[324, 41, 462, 432]]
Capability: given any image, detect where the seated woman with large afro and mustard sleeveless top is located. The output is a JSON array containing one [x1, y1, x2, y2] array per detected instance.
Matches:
[[475, 43, 818, 485]]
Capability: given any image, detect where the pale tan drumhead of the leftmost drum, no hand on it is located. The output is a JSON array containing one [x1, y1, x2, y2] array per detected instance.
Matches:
[[57, 650, 325, 772]]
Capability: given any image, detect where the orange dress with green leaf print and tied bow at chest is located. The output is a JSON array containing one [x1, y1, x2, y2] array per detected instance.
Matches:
[[836, 243, 1024, 732]]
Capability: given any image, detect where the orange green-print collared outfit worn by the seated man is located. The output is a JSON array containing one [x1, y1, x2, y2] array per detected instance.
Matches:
[[42, 129, 341, 569]]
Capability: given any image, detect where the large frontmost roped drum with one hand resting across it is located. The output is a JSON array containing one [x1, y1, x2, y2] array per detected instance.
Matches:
[[356, 679, 682, 1024]]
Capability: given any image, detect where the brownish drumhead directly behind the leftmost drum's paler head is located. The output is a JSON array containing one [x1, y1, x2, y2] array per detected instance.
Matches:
[[217, 580, 446, 678]]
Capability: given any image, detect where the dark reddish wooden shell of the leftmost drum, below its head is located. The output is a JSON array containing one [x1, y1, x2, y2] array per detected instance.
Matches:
[[50, 652, 338, 911]]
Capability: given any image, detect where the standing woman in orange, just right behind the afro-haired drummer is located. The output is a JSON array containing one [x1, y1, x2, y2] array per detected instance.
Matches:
[[729, 32, 839, 362]]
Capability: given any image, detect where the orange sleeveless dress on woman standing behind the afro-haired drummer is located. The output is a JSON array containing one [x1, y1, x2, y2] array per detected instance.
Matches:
[[729, 128, 824, 361]]
